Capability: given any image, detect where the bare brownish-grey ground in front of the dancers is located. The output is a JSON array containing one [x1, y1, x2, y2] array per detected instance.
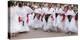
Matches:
[[11, 30, 77, 39]]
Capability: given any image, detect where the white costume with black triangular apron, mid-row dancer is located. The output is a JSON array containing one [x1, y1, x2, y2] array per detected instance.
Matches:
[[42, 7, 53, 31]]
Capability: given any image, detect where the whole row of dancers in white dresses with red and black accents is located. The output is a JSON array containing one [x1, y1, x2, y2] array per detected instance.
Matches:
[[10, 2, 78, 34]]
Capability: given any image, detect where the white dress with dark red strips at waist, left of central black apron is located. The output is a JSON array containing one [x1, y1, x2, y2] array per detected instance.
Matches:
[[32, 8, 42, 28]]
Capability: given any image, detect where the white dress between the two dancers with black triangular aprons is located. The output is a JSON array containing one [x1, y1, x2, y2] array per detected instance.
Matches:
[[56, 8, 64, 31]]
